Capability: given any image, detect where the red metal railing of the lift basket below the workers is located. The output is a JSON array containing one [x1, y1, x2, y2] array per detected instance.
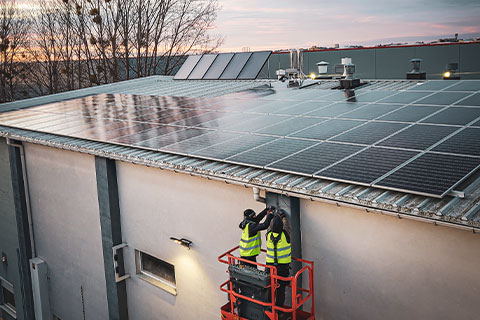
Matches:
[[218, 246, 315, 320]]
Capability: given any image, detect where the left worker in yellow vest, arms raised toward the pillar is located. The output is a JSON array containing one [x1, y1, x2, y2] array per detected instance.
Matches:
[[238, 206, 275, 264]]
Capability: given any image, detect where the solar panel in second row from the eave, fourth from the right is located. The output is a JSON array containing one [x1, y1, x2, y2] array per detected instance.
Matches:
[[292, 119, 364, 140]]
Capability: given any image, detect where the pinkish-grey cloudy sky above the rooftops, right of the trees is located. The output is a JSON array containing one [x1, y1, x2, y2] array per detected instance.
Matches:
[[17, 0, 480, 52]]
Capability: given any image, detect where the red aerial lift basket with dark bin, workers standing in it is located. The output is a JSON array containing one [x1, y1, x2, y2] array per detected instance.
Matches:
[[218, 246, 315, 320]]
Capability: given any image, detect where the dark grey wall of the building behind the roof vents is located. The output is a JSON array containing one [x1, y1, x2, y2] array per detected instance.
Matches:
[[262, 43, 480, 79]]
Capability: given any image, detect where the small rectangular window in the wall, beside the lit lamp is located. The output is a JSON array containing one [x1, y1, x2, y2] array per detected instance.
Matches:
[[135, 250, 177, 295]]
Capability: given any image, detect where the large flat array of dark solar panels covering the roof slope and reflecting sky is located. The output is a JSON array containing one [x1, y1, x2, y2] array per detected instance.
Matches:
[[0, 79, 480, 197]]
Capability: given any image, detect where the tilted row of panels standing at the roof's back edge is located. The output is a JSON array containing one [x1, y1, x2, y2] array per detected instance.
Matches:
[[173, 51, 272, 80]]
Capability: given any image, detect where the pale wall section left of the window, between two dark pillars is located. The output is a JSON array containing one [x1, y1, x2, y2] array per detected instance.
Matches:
[[25, 144, 108, 320]]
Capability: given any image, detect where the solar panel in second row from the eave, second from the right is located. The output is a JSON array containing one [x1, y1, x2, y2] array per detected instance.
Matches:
[[378, 124, 458, 150]]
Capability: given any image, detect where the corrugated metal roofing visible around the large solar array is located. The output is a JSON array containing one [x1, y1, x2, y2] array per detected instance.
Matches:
[[0, 76, 480, 231]]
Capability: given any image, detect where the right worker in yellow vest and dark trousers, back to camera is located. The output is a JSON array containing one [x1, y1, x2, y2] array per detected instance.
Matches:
[[266, 212, 292, 307]]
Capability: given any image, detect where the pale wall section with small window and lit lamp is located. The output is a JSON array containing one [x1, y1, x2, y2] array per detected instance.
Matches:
[[117, 163, 262, 320]]
